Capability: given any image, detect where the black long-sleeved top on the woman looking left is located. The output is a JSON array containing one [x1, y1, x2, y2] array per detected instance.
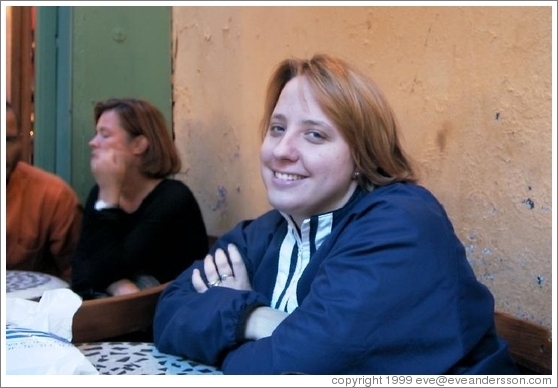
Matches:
[[71, 179, 209, 299]]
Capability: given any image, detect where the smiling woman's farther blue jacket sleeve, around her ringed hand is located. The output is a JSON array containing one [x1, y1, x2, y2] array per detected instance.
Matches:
[[153, 223, 276, 365]]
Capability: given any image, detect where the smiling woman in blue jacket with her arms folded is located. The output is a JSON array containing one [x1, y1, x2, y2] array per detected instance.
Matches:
[[153, 55, 518, 375]]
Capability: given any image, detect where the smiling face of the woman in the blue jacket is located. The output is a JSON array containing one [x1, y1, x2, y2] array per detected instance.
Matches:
[[260, 76, 357, 225]]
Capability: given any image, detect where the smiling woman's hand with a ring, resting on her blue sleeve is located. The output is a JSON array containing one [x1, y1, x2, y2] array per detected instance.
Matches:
[[192, 244, 252, 293]]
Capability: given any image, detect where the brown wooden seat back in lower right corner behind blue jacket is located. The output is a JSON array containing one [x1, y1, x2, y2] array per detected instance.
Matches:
[[494, 311, 552, 375]]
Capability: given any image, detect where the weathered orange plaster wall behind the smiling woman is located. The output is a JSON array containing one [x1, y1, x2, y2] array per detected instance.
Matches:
[[173, 6, 553, 326]]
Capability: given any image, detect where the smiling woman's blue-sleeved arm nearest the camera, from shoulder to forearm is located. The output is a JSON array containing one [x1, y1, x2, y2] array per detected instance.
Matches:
[[221, 196, 493, 374]]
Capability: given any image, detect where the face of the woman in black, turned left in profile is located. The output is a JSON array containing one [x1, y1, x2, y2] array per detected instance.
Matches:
[[89, 110, 135, 159]]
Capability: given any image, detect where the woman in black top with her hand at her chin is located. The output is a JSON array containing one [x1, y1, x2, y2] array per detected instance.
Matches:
[[72, 99, 208, 299]]
